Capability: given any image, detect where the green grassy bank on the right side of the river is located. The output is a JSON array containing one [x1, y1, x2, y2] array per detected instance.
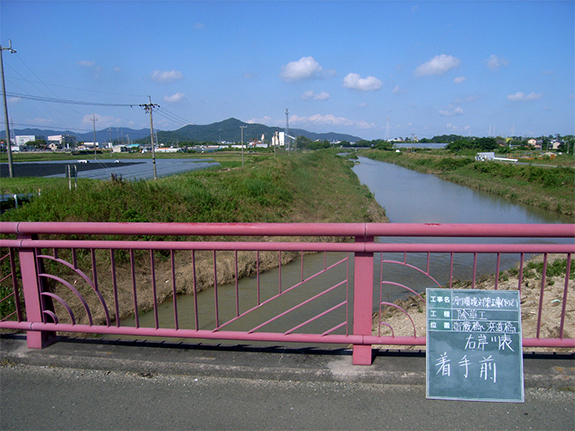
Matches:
[[361, 150, 575, 219]]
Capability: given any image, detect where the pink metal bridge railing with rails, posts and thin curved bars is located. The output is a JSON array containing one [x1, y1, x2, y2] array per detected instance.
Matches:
[[0, 222, 575, 364]]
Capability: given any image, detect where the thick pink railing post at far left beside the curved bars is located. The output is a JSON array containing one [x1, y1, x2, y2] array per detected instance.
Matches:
[[18, 235, 56, 349]]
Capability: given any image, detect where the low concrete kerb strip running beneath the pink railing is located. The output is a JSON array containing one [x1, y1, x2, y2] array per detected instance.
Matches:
[[0, 335, 575, 390]]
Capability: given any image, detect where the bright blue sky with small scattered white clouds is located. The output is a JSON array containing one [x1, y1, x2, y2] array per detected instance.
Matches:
[[0, 0, 575, 139]]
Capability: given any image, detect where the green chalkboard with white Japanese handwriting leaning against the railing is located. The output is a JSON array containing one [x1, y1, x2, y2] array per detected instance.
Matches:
[[426, 288, 525, 402]]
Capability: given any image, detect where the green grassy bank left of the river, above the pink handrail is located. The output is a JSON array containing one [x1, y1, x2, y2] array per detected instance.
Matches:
[[0, 151, 386, 223]]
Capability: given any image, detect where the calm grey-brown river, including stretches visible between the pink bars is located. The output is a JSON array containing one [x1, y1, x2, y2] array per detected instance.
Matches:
[[112, 157, 571, 342]]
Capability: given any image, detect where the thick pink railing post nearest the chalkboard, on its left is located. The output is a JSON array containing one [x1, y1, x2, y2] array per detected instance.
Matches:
[[353, 237, 373, 365]]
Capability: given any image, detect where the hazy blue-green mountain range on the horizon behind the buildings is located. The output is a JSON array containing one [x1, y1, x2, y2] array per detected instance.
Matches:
[[4, 118, 361, 145]]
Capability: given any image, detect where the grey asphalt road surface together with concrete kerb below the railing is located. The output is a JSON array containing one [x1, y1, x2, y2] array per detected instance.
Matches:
[[0, 336, 575, 431]]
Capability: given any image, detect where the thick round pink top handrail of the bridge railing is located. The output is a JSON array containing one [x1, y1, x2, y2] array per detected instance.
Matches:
[[0, 222, 575, 238]]
